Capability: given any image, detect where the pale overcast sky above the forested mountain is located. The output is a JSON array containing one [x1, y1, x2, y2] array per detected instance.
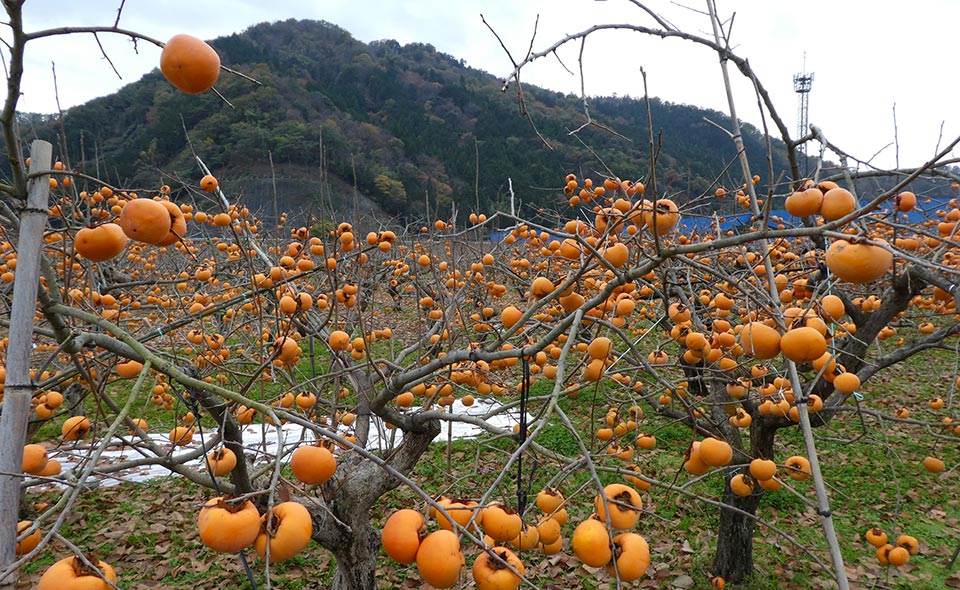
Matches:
[[4, 0, 960, 176]]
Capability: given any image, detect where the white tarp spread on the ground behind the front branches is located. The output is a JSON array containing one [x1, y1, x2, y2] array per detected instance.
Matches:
[[37, 399, 531, 485]]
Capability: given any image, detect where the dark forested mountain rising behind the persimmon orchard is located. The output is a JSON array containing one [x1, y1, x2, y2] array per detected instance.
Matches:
[[29, 20, 804, 225]]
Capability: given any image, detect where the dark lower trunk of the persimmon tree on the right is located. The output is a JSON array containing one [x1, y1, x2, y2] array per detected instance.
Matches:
[[713, 478, 763, 583]]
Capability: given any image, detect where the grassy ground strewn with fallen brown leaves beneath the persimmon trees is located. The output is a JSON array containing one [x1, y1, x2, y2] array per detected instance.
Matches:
[[18, 336, 960, 590]]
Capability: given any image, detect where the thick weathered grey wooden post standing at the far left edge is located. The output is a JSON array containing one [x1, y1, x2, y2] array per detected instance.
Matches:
[[0, 139, 53, 590]]
